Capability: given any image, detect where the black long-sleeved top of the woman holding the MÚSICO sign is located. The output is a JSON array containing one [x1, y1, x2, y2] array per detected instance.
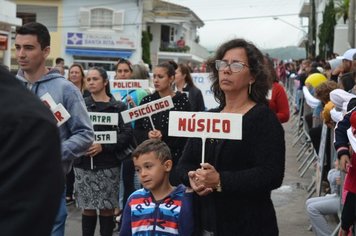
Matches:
[[177, 105, 285, 236]]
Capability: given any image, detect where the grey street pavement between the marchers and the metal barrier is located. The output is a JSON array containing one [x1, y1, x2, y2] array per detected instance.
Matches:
[[65, 122, 328, 236]]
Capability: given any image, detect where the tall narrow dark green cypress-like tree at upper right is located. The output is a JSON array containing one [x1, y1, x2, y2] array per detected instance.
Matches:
[[318, 0, 336, 58]]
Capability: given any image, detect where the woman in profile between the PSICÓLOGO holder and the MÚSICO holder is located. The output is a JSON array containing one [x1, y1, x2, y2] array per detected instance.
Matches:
[[174, 63, 205, 111]]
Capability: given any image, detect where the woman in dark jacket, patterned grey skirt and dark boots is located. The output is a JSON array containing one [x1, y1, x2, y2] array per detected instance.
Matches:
[[74, 67, 133, 236]]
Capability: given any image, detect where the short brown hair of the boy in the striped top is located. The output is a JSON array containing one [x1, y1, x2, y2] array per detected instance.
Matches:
[[132, 139, 172, 163]]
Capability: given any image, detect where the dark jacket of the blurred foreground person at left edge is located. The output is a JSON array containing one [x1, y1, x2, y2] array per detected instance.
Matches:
[[0, 66, 64, 236]]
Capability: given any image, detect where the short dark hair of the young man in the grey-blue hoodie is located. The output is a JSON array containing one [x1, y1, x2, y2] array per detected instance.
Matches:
[[16, 22, 51, 50]]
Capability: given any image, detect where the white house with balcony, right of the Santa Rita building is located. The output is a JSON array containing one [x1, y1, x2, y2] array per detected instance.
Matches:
[[143, 0, 209, 66]]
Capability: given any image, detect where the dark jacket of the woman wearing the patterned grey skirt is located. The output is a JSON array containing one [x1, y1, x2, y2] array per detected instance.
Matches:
[[74, 96, 133, 170]]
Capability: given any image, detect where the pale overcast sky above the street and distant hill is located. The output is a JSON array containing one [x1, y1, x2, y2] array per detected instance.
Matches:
[[165, 0, 307, 50]]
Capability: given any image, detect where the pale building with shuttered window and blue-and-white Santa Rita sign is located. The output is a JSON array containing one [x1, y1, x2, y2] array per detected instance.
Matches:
[[62, 0, 143, 70]]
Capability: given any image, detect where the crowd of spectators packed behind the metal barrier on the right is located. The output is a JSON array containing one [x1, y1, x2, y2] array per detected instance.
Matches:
[[277, 45, 356, 236]]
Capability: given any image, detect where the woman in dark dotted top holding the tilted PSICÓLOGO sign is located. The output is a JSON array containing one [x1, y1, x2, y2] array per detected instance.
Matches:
[[135, 62, 190, 186]]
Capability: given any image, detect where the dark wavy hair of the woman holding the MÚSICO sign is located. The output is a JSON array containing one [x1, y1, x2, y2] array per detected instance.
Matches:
[[207, 39, 270, 108]]
